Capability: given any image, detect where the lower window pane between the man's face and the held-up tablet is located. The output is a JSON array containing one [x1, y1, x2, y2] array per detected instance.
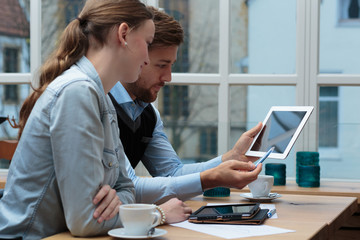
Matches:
[[158, 85, 218, 163]]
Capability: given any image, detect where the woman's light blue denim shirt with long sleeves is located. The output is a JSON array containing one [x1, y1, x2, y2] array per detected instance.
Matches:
[[0, 57, 135, 239]]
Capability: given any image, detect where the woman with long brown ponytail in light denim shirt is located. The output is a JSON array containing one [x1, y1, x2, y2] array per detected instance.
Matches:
[[0, 0, 188, 239]]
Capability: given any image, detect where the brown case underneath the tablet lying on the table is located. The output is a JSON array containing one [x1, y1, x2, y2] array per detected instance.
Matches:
[[189, 209, 269, 225]]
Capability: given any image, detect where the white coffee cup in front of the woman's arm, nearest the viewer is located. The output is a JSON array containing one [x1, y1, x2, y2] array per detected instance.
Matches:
[[119, 203, 161, 236]]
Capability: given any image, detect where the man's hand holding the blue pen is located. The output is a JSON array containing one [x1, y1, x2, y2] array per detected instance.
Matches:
[[200, 160, 262, 190]]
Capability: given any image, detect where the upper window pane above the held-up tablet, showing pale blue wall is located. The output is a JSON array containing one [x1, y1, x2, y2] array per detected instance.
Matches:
[[230, 0, 296, 74]]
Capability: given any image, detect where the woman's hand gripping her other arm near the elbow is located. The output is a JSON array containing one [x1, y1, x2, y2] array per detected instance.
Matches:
[[93, 185, 122, 223]]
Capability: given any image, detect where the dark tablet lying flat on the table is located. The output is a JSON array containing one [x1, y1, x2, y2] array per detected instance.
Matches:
[[189, 203, 260, 223]]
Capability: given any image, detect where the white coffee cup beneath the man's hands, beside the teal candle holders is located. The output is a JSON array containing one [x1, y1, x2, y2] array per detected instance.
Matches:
[[248, 175, 274, 198]]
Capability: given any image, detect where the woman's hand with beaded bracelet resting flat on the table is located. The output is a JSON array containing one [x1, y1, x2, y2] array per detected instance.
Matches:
[[159, 198, 192, 224]]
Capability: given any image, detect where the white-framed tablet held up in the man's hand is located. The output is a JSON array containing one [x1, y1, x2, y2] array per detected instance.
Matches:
[[245, 106, 314, 159]]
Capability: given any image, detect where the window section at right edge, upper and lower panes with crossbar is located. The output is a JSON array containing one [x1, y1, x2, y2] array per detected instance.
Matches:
[[320, 0, 360, 179]]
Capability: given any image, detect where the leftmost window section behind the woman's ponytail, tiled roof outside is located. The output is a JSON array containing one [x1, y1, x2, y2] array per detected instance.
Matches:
[[0, 0, 30, 142]]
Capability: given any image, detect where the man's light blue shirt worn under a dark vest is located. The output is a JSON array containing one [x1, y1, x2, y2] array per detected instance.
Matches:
[[110, 82, 222, 203]]
